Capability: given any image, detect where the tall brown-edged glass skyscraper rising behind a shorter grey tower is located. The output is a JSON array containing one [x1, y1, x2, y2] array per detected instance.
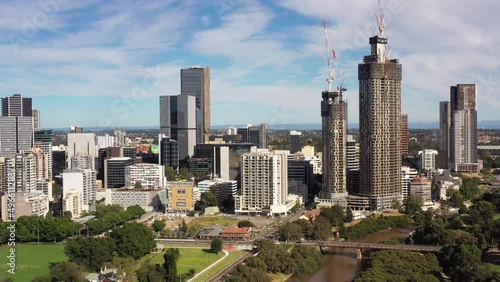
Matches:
[[181, 66, 210, 144]]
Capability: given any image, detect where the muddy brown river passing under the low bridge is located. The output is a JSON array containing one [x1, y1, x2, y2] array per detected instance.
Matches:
[[287, 228, 414, 282]]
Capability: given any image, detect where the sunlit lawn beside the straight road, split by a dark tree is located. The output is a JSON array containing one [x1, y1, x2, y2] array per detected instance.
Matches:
[[137, 246, 224, 274]]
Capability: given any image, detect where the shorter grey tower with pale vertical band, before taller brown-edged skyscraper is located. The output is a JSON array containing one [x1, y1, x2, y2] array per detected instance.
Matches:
[[160, 95, 197, 160]]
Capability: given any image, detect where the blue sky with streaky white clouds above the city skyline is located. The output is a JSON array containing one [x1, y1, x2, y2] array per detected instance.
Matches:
[[0, 0, 500, 128]]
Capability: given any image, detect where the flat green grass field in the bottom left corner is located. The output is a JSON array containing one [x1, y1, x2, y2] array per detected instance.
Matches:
[[0, 244, 67, 282]]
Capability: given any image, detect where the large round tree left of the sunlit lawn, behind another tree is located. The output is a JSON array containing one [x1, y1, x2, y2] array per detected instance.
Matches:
[[110, 222, 156, 259]]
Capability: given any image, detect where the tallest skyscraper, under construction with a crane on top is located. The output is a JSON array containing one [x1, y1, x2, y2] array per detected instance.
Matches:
[[358, 20, 402, 210]]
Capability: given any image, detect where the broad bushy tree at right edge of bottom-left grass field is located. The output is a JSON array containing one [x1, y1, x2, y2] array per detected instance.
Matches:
[[64, 236, 114, 271]]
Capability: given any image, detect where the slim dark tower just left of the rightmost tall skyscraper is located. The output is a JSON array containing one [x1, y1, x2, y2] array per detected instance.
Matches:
[[438, 101, 451, 169]]
